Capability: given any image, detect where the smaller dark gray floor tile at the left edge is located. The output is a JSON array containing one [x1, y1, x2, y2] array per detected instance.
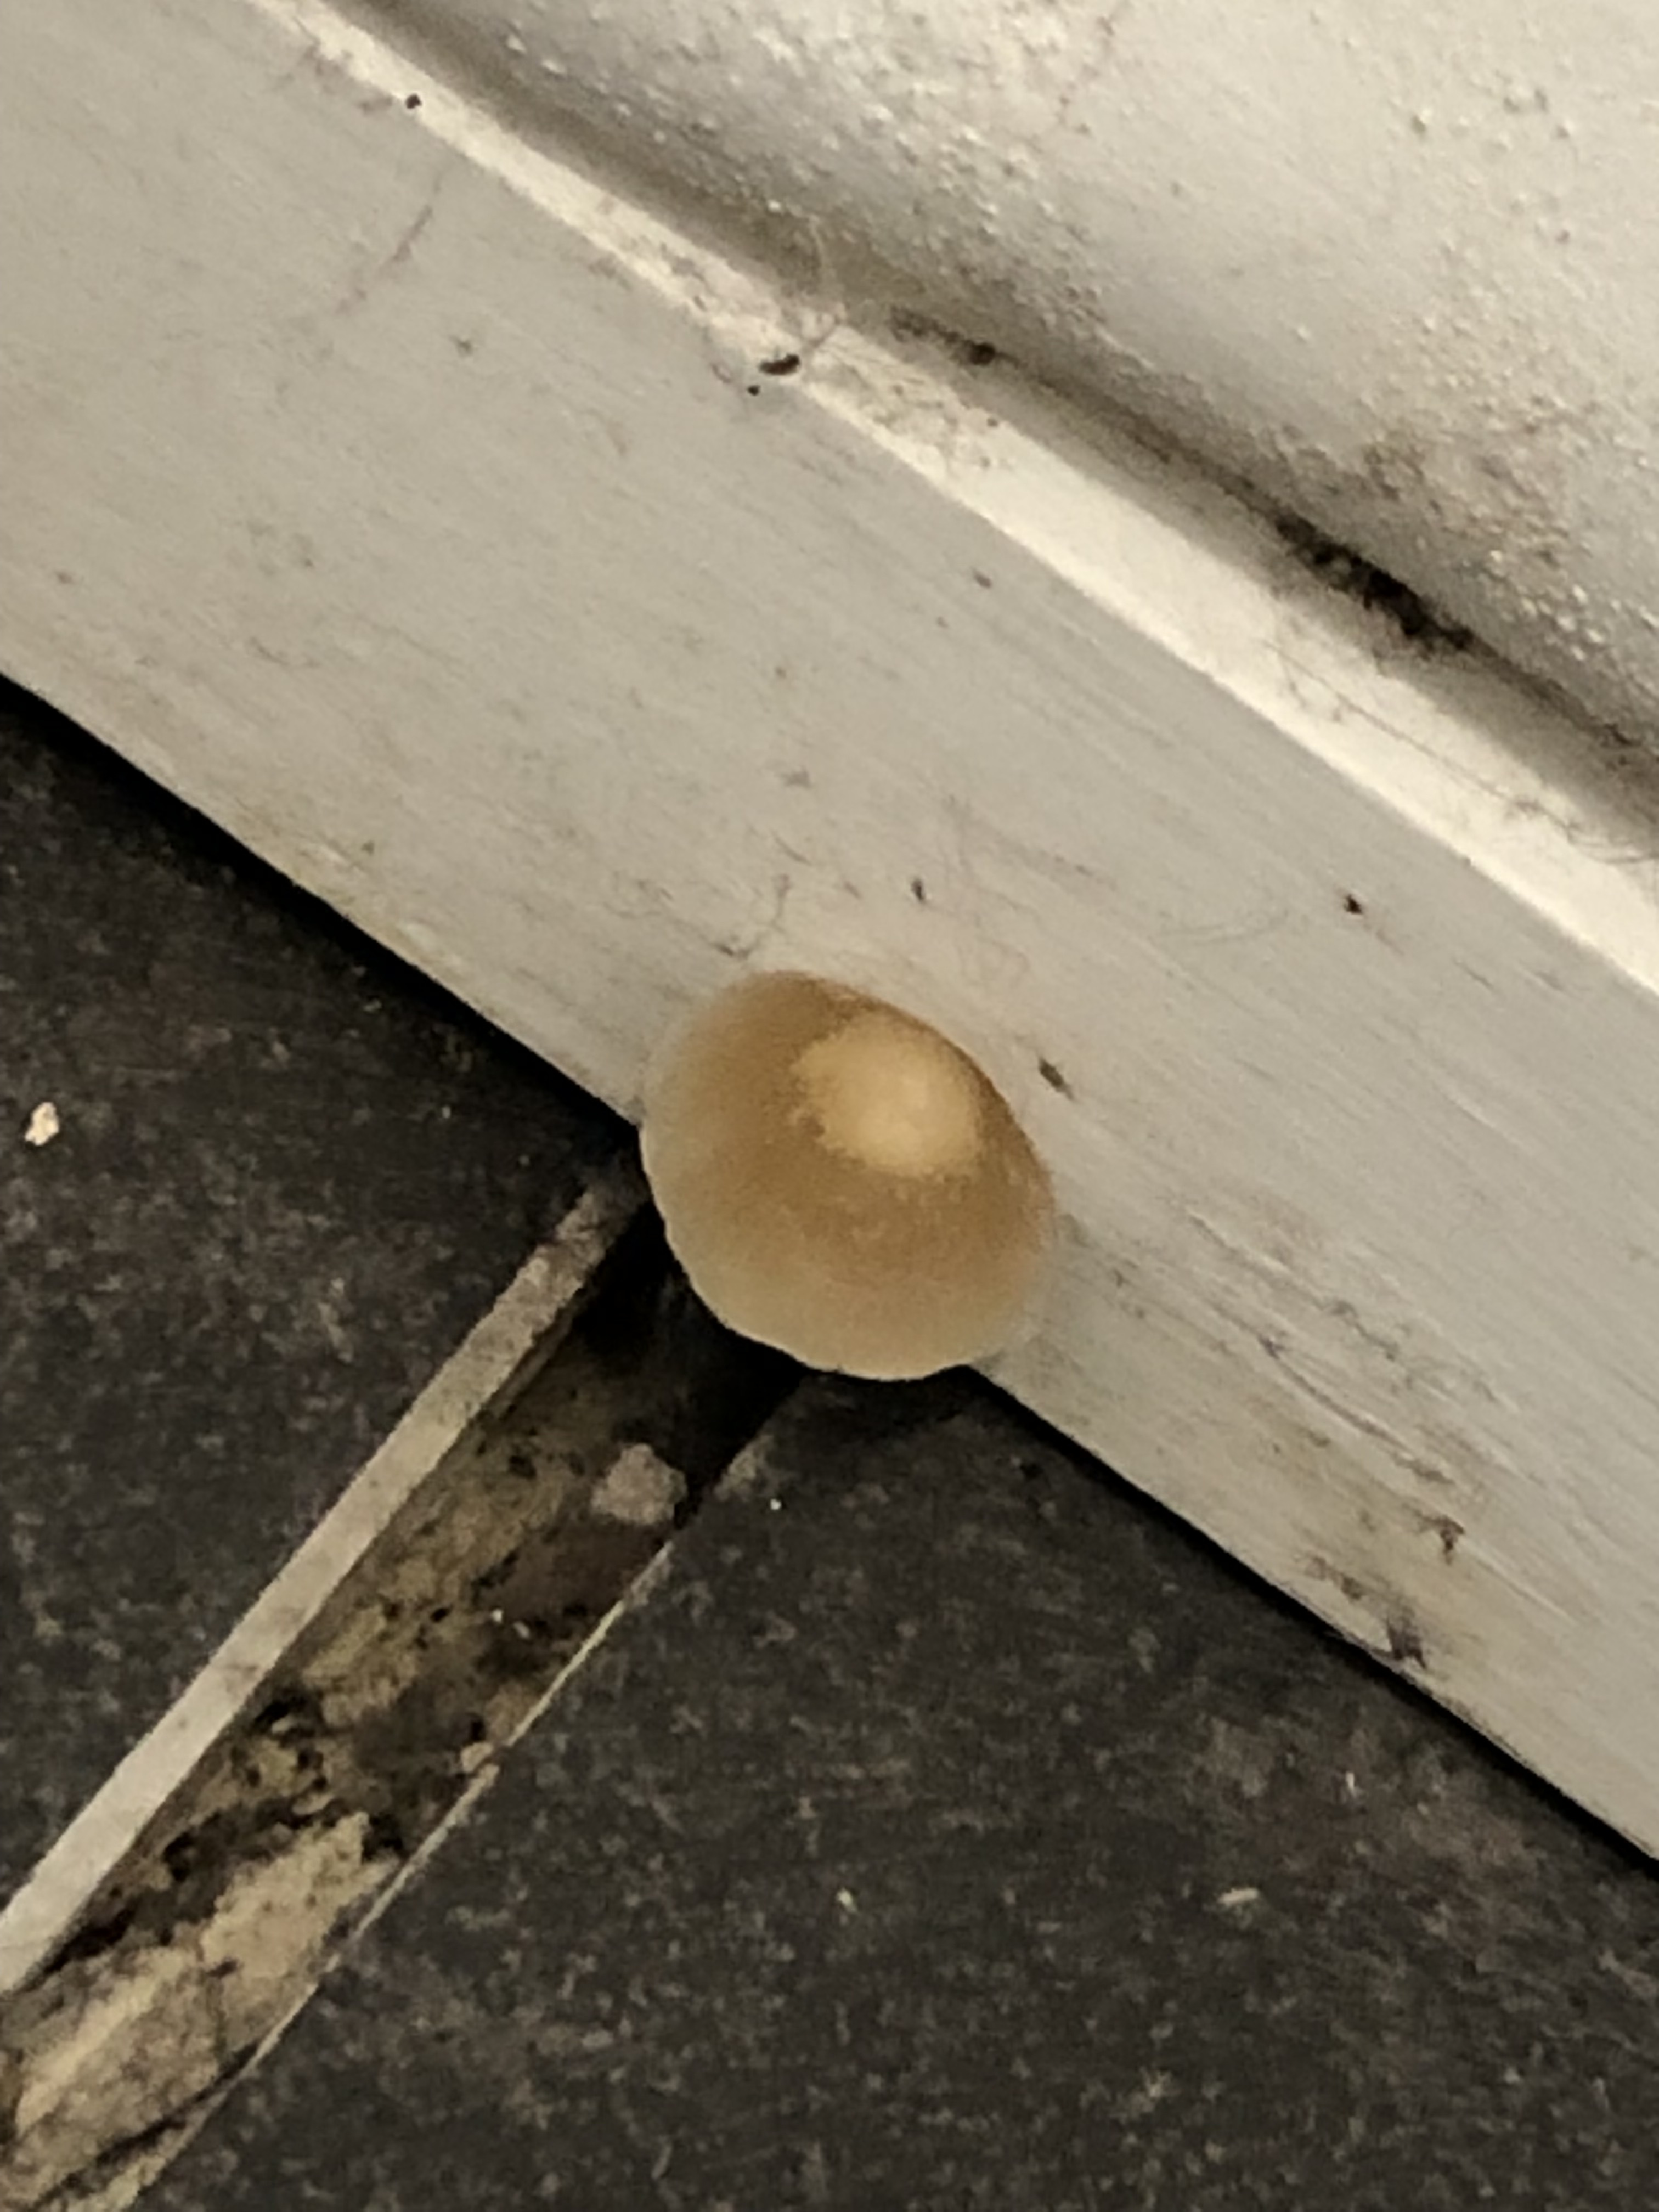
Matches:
[[0, 688, 622, 1891]]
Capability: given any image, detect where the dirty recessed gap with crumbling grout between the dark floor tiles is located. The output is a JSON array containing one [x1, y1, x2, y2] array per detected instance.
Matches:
[[0, 1219, 794, 2212]]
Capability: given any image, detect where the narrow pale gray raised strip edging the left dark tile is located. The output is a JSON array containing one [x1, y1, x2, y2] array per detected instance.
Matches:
[[0, 1170, 641, 1997]]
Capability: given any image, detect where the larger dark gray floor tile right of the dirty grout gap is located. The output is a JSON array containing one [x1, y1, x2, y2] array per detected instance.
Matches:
[[150, 1383, 1659, 2212]]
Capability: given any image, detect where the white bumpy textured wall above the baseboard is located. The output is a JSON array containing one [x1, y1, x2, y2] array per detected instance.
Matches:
[[381, 0, 1659, 739]]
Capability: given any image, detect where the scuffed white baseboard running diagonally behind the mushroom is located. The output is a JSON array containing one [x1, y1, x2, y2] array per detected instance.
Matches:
[[13, 0, 1659, 1849]]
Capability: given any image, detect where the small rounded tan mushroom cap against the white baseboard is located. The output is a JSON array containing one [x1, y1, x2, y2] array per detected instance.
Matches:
[[641, 973, 1053, 1380]]
